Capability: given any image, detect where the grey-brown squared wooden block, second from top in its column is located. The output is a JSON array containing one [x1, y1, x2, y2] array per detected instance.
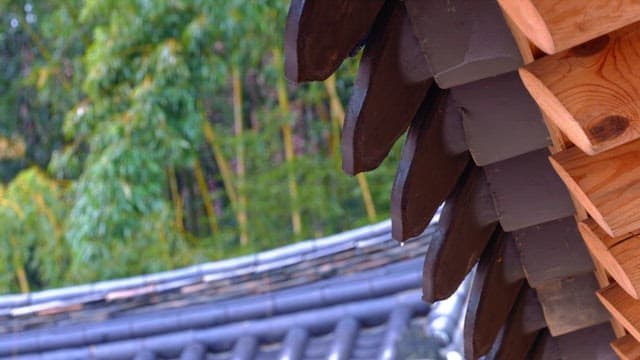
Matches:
[[451, 72, 551, 166]]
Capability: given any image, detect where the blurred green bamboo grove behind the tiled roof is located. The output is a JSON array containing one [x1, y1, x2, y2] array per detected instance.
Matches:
[[0, 0, 398, 292]]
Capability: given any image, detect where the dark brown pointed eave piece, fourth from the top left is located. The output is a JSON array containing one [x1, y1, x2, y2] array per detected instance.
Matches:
[[422, 165, 498, 303]]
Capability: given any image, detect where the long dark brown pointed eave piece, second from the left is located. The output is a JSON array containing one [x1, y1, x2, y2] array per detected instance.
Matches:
[[342, 1, 432, 175]]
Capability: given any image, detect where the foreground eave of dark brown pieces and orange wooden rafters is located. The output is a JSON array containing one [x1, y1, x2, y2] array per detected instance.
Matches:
[[285, 0, 640, 359]]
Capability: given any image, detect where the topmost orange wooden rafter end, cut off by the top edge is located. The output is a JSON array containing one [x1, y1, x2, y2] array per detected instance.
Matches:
[[498, 0, 640, 54]]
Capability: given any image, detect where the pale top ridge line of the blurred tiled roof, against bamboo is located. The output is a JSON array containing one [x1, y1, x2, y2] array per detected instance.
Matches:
[[0, 220, 391, 308]]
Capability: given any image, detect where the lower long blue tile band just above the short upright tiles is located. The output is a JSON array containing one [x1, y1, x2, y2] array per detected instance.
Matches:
[[12, 289, 429, 360]]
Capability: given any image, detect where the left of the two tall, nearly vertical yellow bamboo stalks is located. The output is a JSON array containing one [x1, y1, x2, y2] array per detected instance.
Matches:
[[231, 66, 249, 246]]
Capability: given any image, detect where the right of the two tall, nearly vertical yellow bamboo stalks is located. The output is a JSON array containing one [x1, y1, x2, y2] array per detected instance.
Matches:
[[273, 48, 302, 236]]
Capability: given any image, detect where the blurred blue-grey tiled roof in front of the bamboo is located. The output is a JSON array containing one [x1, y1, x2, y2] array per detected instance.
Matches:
[[0, 221, 468, 360]]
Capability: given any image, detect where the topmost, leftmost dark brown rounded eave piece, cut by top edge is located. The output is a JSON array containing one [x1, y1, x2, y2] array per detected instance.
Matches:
[[284, 0, 385, 82]]
